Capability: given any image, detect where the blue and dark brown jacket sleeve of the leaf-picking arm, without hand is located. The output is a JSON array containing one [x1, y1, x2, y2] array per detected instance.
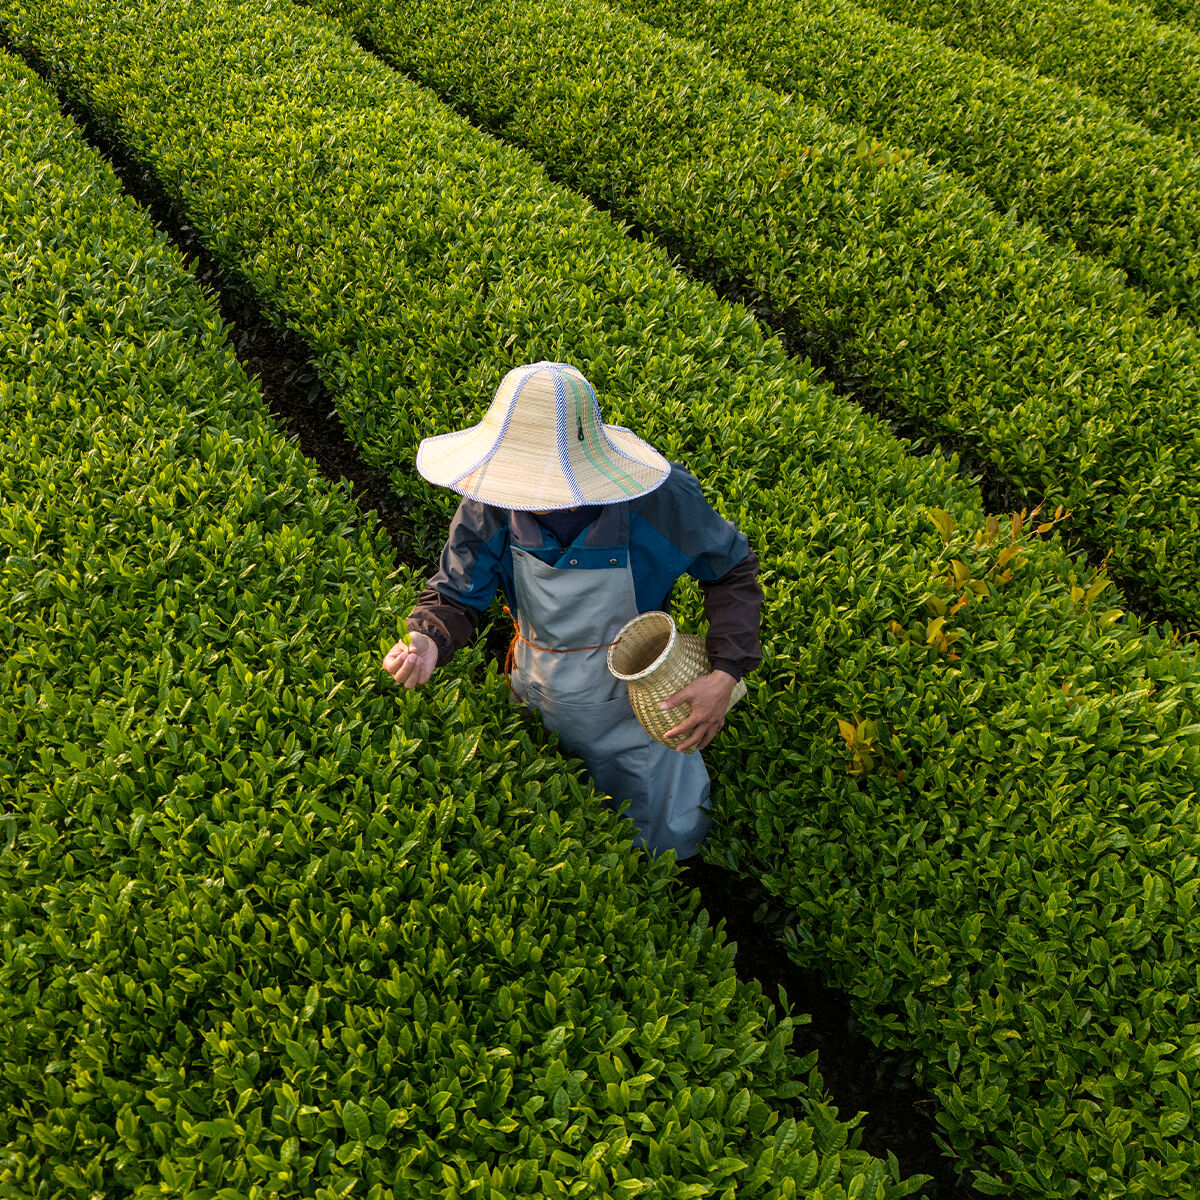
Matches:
[[407, 499, 508, 667]]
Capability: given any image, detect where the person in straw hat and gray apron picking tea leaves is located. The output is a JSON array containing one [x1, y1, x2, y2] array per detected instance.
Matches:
[[383, 362, 762, 860]]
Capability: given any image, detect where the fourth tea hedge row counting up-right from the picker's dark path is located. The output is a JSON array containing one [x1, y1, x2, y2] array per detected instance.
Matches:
[[862, 0, 1200, 139]]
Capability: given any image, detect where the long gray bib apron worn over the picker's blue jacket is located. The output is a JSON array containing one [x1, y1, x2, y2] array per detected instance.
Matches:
[[512, 546, 709, 860]]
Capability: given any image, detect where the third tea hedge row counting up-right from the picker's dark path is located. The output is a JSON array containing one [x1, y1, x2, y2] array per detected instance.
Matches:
[[617, 0, 1200, 323]]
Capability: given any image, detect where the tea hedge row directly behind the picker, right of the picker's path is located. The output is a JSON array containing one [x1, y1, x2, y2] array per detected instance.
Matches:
[[5, 0, 1200, 1196]]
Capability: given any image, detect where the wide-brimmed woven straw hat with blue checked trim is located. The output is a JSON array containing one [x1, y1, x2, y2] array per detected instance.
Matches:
[[416, 362, 671, 511]]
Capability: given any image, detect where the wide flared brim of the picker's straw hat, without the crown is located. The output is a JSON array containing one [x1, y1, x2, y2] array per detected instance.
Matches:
[[416, 424, 671, 512]]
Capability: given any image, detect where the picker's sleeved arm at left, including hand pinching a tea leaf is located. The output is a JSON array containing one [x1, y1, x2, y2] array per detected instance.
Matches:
[[383, 500, 508, 688]]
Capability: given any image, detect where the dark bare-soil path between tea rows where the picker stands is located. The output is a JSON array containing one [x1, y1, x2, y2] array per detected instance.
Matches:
[[18, 38, 1003, 1200]]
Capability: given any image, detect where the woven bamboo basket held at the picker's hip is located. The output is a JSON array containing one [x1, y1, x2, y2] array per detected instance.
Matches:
[[608, 612, 746, 754]]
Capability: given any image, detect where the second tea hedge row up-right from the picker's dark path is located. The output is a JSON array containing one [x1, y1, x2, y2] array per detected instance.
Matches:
[[302, 0, 1200, 622]]
